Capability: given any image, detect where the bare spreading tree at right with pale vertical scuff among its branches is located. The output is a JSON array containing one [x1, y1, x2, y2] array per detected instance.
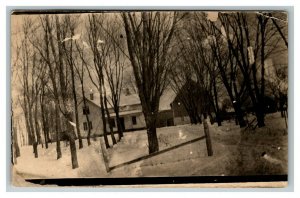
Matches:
[[219, 12, 282, 127]]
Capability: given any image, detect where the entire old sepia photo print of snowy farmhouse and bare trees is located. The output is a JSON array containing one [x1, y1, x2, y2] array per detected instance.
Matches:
[[10, 10, 288, 186]]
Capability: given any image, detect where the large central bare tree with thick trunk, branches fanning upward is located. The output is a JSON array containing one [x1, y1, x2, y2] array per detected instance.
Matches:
[[122, 12, 179, 153]]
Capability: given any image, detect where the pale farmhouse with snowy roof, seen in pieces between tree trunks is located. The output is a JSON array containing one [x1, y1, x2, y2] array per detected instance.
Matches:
[[78, 89, 176, 137]]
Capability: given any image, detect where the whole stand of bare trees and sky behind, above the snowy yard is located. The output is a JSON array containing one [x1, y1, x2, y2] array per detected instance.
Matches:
[[12, 11, 288, 168]]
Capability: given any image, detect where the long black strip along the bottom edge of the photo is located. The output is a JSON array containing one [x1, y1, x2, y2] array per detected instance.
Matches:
[[26, 175, 288, 187]]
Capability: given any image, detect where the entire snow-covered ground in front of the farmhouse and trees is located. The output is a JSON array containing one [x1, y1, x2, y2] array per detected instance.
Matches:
[[14, 114, 288, 184]]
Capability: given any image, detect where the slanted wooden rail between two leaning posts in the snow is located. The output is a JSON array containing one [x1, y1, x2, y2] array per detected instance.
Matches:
[[109, 136, 205, 170]]
